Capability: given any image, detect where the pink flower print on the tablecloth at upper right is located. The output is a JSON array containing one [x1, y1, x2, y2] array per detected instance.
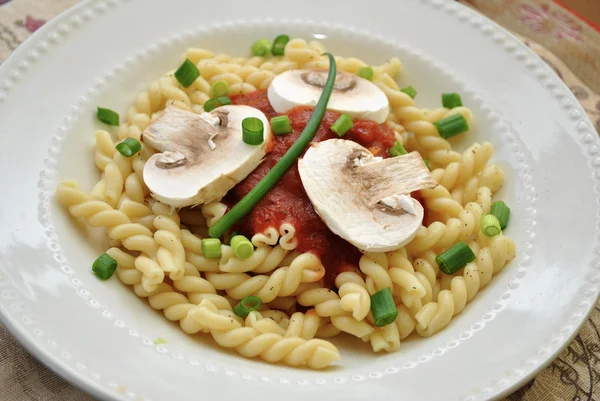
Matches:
[[520, 4, 583, 42]]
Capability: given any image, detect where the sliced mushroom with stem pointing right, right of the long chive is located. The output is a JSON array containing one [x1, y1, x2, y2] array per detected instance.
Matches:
[[298, 139, 437, 252]]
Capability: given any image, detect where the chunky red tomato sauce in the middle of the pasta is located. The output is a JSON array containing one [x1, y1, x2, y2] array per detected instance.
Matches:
[[225, 91, 394, 285]]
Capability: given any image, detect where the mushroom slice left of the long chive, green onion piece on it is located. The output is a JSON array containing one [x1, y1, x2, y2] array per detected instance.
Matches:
[[142, 106, 271, 207]]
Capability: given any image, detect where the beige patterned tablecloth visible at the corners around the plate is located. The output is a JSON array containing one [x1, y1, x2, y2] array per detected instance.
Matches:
[[0, 0, 600, 401]]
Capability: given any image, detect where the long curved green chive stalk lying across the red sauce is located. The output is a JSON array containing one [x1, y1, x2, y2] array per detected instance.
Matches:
[[208, 53, 337, 238]]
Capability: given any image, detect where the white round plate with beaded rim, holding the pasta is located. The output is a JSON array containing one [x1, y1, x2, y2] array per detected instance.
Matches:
[[0, 0, 600, 401]]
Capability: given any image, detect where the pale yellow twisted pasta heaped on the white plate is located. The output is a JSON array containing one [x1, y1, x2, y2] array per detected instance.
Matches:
[[57, 38, 516, 369]]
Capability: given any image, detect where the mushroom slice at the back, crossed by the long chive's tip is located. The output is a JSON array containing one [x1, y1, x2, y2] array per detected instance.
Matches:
[[267, 70, 390, 123]]
